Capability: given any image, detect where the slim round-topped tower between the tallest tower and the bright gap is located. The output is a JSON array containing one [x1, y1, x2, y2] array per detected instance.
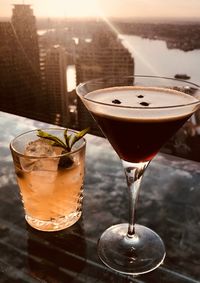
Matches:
[[44, 45, 69, 125]]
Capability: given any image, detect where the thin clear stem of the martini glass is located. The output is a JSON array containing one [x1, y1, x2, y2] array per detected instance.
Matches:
[[122, 160, 149, 238]]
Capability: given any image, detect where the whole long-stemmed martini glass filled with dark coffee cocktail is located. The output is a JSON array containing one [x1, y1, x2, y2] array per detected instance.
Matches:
[[76, 76, 200, 275]]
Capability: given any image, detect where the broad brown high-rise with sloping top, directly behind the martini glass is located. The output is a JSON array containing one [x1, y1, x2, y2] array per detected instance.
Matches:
[[76, 27, 134, 135]]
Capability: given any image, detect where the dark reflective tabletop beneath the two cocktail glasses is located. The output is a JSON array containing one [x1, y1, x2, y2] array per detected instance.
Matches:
[[0, 112, 200, 283]]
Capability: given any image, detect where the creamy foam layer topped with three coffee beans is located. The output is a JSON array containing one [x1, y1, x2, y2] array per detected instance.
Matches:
[[85, 86, 198, 120]]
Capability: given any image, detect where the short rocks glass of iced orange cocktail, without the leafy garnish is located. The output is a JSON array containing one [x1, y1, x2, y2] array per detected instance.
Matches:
[[10, 129, 86, 231]]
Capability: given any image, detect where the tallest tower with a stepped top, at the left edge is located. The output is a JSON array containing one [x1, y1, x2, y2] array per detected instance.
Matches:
[[0, 5, 45, 120]]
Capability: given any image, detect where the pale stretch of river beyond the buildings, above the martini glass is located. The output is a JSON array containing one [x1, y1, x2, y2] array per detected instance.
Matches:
[[120, 35, 200, 84]]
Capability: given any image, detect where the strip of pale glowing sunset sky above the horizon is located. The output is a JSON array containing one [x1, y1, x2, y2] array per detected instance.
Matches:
[[0, 0, 200, 20]]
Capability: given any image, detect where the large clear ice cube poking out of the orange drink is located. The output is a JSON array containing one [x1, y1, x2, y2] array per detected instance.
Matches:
[[21, 139, 62, 172]]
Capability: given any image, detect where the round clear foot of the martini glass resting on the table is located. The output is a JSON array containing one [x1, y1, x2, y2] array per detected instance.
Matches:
[[98, 223, 165, 275]]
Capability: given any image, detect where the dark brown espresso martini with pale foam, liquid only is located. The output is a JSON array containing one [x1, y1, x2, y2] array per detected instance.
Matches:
[[85, 86, 197, 163]]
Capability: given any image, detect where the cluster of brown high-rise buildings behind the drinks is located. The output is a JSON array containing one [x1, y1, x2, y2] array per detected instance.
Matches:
[[0, 1, 134, 131]]
